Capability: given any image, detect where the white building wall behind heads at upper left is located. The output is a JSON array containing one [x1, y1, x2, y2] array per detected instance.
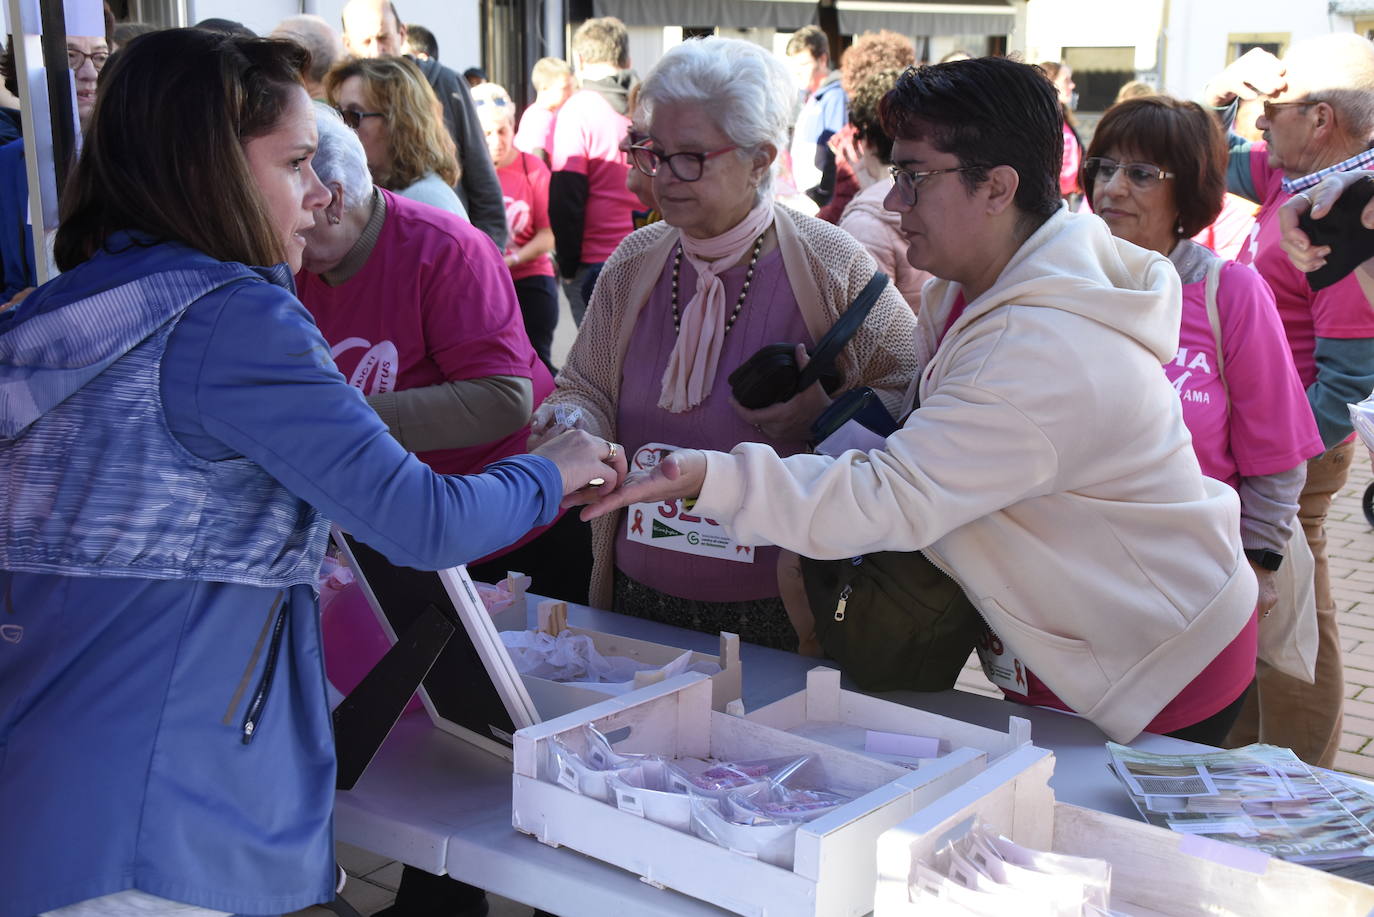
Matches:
[[187, 0, 482, 73]]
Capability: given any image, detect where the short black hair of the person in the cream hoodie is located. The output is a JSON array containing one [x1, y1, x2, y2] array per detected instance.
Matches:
[[878, 58, 1063, 220]]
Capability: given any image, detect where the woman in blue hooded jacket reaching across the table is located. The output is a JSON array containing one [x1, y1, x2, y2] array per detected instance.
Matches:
[[0, 30, 624, 917]]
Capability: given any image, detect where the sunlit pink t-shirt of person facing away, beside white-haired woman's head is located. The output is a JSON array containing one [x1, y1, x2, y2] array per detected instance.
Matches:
[[548, 89, 643, 264]]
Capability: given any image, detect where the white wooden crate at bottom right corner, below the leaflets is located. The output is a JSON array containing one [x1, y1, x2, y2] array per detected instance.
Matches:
[[874, 747, 1374, 917]]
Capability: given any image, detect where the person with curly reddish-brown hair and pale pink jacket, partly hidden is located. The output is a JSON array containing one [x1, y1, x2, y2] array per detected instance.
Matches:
[[840, 70, 930, 313]]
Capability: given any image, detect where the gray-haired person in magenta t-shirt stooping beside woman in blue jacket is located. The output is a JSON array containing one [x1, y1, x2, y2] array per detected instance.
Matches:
[[295, 103, 589, 601]]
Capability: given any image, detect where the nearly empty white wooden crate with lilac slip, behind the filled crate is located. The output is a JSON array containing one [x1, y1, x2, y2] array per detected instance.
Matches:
[[745, 665, 1031, 762]]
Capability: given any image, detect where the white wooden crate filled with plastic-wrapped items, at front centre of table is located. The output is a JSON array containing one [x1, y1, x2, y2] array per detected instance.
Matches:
[[513, 674, 988, 917]]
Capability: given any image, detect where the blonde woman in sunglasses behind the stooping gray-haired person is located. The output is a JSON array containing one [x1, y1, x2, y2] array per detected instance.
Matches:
[[324, 58, 467, 219]]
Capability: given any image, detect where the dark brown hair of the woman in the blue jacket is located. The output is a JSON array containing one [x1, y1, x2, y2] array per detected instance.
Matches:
[[54, 29, 309, 271]]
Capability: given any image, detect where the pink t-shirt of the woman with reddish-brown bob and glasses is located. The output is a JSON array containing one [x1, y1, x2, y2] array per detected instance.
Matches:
[[1164, 263, 1323, 487]]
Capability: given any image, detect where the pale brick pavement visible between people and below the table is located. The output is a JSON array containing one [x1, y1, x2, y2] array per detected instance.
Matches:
[[309, 452, 1374, 917]]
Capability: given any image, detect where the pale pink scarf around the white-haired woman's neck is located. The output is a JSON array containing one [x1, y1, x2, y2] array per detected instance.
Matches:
[[658, 204, 774, 414]]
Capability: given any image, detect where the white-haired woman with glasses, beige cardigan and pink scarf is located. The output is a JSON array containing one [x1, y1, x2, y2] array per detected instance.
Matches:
[[532, 38, 916, 648]]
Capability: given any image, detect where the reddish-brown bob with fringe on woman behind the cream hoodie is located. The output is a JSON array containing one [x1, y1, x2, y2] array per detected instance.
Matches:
[[1083, 95, 1227, 239]]
